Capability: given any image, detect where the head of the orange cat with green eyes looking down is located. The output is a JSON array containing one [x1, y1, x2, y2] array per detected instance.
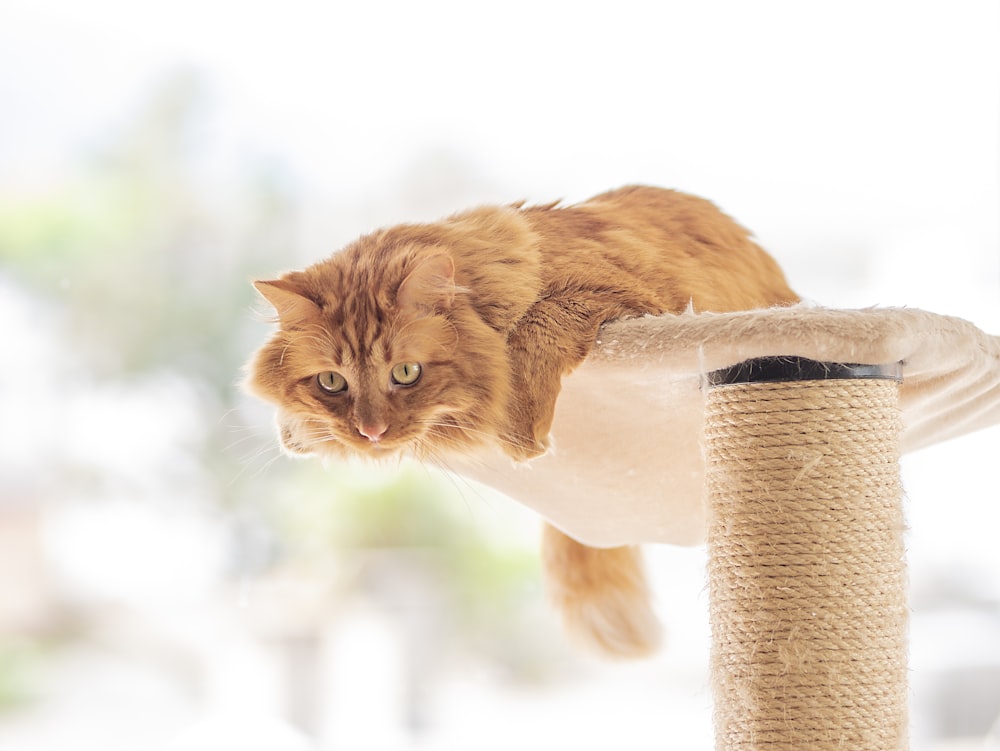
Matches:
[[246, 232, 509, 458]]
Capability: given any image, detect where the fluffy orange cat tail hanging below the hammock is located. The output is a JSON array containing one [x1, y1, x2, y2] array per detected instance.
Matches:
[[542, 524, 662, 657]]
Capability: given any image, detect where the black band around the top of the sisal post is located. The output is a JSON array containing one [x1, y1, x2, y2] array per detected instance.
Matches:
[[706, 357, 903, 386]]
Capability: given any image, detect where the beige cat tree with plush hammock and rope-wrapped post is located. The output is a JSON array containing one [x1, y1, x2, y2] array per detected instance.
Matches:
[[458, 306, 1000, 751]]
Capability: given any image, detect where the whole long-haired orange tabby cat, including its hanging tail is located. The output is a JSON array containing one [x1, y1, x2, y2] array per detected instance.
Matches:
[[248, 186, 798, 655]]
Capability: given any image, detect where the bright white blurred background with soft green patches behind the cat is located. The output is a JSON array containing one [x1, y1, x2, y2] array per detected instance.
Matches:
[[0, 0, 1000, 751]]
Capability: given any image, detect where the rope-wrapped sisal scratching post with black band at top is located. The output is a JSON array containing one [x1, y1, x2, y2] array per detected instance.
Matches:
[[705, 358, 907, 751]]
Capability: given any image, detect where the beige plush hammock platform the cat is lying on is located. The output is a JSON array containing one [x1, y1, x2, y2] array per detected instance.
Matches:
[[460, 306, 1000, 547]]
